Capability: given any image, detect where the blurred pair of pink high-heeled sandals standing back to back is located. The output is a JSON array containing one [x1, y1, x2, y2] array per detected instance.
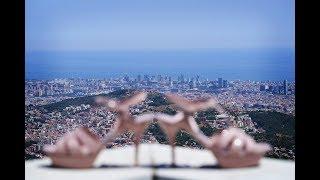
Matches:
[[44, 92, 271, 168]]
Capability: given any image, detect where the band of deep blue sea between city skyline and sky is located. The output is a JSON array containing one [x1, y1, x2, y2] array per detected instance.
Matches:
[[25, 49, 295, 81]]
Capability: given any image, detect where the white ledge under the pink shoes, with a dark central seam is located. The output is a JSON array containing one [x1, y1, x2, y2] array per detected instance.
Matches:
[[25, 144, 295, 180]]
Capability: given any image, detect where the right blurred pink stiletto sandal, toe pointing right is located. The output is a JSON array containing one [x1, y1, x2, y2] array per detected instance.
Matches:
[[156, 94, 271, 168]]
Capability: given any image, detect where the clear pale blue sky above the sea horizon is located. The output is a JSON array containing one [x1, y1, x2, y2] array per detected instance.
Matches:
[[25, 0, 295, 52]]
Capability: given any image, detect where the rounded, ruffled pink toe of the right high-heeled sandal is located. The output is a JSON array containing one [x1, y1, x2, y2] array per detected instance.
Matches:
[[209, 128, 271, 168]]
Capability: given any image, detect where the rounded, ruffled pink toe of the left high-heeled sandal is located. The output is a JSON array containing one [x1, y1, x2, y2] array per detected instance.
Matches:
[[43, 128, 103, 168]]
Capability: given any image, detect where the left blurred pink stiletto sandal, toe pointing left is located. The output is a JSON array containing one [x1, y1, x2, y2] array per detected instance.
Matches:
[[44, 93, 154, 168]]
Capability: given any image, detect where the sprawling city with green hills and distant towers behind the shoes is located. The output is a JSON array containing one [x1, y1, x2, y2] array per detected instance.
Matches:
[[25, 74, 295, 160]]
